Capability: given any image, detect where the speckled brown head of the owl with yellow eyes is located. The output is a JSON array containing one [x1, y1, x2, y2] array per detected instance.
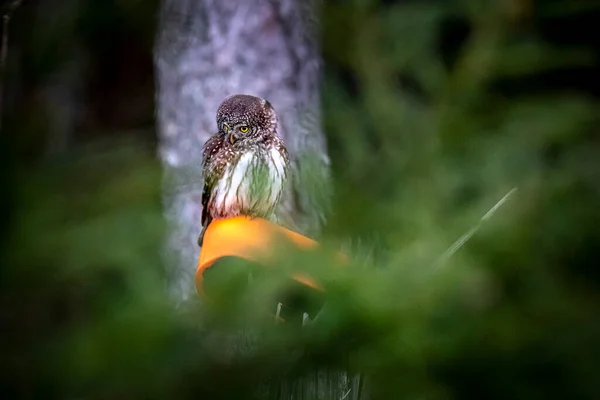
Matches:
[[217, 94, 277, 144]]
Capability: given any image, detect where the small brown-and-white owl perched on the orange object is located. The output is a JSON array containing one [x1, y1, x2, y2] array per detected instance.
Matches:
[[198, 94, 290, 246]]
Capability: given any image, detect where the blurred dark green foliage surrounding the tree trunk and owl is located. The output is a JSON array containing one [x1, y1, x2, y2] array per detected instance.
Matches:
[[0, 0, 600, 399]]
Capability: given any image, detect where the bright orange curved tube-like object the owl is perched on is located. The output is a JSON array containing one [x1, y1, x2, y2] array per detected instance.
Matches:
[[195, 217, 332, 294]]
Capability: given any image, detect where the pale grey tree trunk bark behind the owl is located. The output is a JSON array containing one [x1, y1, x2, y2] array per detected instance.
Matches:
[[155, 0, 328, 299]]
